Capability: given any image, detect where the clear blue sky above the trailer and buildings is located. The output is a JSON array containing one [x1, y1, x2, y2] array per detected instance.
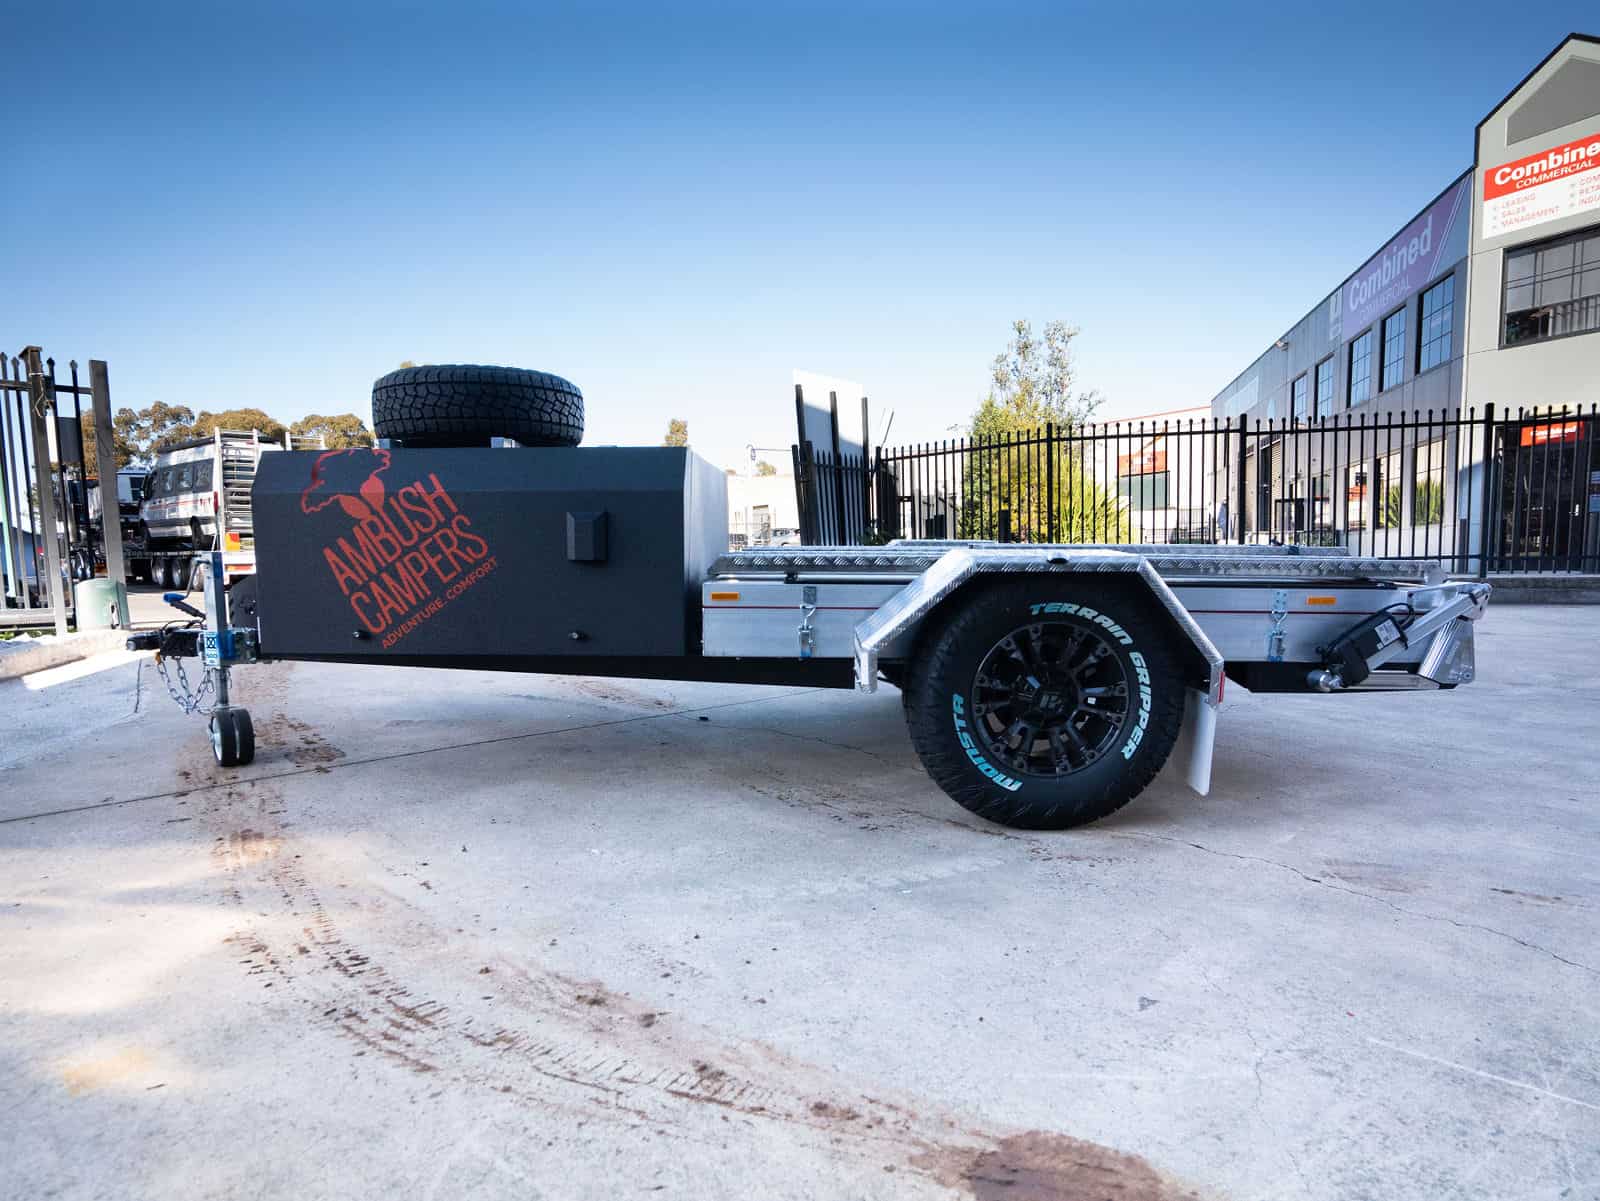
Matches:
[[0, 0, 1600, 461]]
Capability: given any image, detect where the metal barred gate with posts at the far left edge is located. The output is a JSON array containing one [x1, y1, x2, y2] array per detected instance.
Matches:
[[0, 345, 128, 633]]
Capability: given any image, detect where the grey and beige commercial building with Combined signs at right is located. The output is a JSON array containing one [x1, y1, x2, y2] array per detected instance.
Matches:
[[1211, 34, 1600, 569]]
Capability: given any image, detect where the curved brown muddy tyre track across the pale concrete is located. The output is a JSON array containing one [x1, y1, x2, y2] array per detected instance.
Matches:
[[184, 662, 1194, 1201]]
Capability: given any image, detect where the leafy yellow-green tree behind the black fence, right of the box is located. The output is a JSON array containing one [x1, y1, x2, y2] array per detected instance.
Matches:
[[957, 321, 1131, 542]]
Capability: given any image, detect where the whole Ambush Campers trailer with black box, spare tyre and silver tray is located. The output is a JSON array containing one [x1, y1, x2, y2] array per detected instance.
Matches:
[[128, 366, 1490, 828]]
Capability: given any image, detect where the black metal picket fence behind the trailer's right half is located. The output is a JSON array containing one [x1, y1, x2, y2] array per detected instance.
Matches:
[[795, 406, 1600, 576]]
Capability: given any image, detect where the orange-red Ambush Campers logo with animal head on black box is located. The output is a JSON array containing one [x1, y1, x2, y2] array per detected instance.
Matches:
[[301, 446, 496, 649]]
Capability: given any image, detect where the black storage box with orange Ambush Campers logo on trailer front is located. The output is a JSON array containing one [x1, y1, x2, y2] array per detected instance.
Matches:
[[253, 446, 728, 667]]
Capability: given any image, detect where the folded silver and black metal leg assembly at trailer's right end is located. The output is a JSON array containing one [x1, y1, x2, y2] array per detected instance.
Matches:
[[1306, 584, 1491, 692]]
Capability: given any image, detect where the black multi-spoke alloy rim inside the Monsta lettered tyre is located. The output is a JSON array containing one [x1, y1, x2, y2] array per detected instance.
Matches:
[[971, 622, 1131, 779]]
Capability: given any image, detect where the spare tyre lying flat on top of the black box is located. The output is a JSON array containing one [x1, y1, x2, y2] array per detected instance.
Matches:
[[373, 366, 584, 446]]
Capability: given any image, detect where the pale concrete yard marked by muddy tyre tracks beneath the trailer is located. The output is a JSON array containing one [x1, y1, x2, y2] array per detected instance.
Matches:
[[0, 606, 1600, 1201]]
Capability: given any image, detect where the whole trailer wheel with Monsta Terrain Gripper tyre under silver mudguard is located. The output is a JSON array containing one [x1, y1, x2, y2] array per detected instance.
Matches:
[[906, 576, 1184, 830]]
